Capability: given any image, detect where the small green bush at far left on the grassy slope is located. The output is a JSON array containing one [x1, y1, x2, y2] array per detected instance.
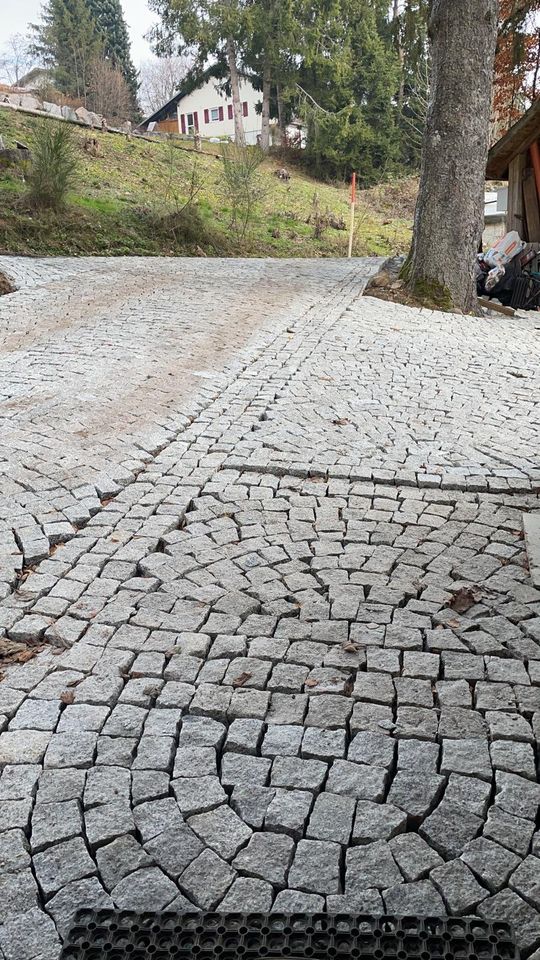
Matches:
[[28, 120, 79, 211]]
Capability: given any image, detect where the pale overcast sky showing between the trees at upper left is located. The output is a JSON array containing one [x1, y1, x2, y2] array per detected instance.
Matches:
[[0, 0, 155, 67]]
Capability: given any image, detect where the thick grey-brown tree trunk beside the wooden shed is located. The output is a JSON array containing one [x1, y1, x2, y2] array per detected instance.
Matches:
[[405, 0, 498, 313]]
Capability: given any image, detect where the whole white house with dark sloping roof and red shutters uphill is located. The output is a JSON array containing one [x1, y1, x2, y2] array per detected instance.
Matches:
[[141, 77, 261, 144]]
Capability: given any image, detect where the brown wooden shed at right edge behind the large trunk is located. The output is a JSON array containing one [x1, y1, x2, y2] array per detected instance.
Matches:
[[486, 100, 540, 245]]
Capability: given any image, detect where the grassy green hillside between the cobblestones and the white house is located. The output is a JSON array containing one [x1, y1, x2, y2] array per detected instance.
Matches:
[[0, 109, 414, 257]]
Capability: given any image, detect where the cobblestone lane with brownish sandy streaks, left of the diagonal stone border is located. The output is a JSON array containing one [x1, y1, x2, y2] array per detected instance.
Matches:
[[0, 258, 362, 597]]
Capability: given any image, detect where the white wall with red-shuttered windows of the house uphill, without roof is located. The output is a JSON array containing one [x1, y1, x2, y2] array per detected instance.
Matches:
[[178, 80, 261, 144]]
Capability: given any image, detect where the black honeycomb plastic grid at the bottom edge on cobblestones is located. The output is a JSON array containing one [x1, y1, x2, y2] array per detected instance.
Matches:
[[61, 910, 519, 960]]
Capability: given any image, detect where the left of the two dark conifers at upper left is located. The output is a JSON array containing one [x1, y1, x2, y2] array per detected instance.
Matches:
[[32, 0, 102, 102]]
